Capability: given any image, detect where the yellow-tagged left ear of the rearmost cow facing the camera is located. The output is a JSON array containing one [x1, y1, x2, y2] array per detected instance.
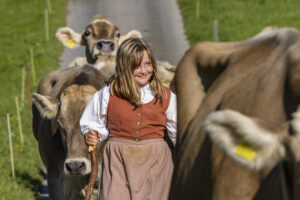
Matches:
[[55, 27, 81, 49]]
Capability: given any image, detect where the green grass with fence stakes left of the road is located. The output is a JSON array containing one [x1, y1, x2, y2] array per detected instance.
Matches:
[[0, 0, 67, 200]]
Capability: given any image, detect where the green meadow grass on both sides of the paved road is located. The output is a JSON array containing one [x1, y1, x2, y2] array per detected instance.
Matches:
[[0, 0, 300, 200]]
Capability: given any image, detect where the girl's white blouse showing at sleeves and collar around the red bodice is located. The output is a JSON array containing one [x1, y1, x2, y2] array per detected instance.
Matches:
[[80, 85, 177, 146]]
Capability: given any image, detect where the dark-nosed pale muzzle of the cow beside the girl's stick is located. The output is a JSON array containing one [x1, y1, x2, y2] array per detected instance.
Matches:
[[64, 158, 91, 175]]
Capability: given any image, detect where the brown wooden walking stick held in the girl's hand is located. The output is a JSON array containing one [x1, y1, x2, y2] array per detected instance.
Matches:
[[84, 145, 98, 200]]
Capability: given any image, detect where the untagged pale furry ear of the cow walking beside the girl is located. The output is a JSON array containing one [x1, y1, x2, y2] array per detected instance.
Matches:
[[32, 93, 59, 119]]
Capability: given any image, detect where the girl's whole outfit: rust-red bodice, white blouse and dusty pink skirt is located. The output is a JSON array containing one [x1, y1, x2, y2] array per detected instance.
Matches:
[[80, 85, 177, 200]]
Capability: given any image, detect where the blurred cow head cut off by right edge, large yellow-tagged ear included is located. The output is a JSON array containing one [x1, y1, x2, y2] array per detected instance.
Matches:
[[204, 110, 300, 170]]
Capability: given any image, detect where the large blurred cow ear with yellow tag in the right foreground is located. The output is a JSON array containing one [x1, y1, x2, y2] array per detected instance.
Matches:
[[204, 110, 286, 170]]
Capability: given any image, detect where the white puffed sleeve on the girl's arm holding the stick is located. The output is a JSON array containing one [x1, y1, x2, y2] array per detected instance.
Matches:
[[79, 86, 110, 141]]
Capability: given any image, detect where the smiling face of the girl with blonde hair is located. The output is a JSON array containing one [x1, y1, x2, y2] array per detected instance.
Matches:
[[133, 51, 153, 86]]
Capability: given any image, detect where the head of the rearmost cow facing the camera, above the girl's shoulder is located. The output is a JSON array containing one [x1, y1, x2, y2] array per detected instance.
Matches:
[[56, 16, 142, 64]]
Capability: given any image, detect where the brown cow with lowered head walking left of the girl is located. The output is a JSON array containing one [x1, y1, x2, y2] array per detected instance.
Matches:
[[32, 65, 111, 200]]
